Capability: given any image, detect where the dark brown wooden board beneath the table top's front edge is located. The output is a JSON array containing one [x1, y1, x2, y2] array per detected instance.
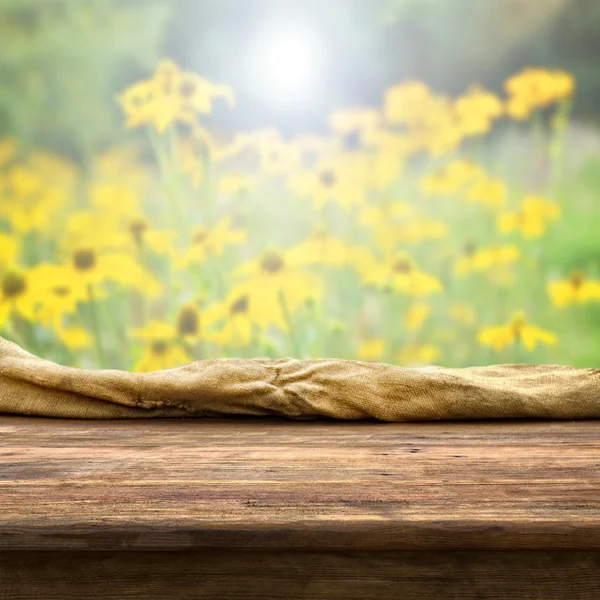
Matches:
[[0, 549, 600, 600]]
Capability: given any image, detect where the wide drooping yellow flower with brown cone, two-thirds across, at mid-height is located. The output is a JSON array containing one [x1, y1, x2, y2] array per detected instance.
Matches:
[[363, 253, 442, 297]]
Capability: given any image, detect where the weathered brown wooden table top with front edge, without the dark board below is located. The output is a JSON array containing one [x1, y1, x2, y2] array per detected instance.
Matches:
[[0, 416, 600, 551]]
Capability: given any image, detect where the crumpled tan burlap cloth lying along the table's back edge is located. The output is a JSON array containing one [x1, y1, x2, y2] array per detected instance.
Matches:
[[0, 338, 600, 421]]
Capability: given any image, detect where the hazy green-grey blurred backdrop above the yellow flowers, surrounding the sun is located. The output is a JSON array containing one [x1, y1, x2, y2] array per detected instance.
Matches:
[[0, 0, 600, 156]]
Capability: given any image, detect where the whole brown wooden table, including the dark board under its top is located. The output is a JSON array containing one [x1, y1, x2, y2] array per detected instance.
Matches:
[[0, 416, 600, 600]]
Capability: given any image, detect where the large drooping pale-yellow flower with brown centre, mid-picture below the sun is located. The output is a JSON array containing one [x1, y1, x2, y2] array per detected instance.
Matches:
[[230, 250, 322, 331]]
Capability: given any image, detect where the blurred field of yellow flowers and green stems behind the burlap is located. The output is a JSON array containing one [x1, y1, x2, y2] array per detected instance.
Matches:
[[0, 60, 600, 371]]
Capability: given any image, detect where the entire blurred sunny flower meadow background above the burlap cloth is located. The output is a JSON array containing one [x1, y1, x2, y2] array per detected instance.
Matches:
[[0, 0, 600, 370]]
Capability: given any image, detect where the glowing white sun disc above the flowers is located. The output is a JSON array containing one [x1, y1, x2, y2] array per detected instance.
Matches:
[[247, 24, 324, 106]]
